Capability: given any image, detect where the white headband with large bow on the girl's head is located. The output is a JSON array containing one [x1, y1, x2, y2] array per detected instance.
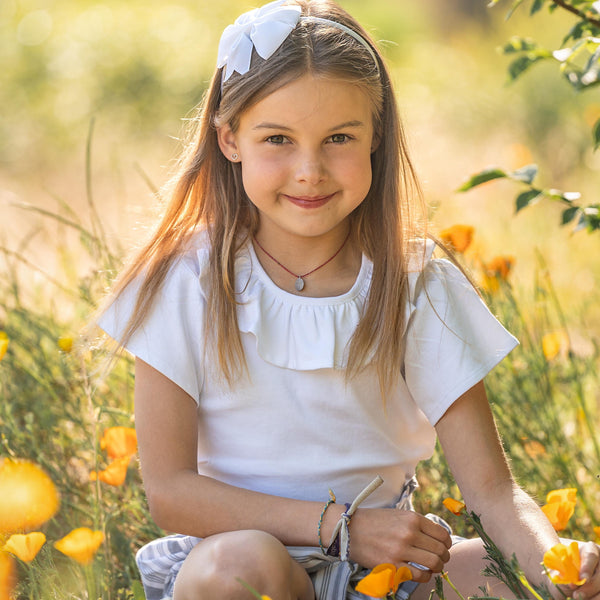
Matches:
[[217, 0, 379, 82]]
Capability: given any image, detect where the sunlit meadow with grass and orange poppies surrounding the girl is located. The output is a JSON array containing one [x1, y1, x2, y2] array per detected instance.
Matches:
[[0, 0, 600, 600]]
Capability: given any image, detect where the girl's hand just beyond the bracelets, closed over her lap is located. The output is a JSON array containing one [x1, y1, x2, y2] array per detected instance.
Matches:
[[332, 508, 452, 582]]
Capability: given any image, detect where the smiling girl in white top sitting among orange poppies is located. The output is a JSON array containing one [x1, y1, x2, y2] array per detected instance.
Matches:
[[100, 0, 600, 600]]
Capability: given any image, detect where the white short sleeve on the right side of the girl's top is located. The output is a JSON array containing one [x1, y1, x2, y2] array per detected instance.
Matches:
[[404, 259, 518, 425]]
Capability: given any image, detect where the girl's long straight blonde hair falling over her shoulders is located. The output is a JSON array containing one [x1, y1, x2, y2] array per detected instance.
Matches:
[[102, 0, 423, 389]]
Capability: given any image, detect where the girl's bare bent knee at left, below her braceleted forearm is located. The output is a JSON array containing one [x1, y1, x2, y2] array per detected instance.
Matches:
[[173, 531, 314, 600]]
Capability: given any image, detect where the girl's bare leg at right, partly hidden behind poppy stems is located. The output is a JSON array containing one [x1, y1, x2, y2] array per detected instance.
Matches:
[[410, 538, 514, 600]]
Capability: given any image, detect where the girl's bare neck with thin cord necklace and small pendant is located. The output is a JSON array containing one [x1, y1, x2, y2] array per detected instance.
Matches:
[[253, 229, 362, 298]]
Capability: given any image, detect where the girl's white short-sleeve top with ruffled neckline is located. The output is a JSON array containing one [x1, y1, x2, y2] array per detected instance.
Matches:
[[100, 234, 517, 506]]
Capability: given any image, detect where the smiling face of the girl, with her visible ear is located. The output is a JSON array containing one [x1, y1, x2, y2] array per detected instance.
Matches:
[[218, 75, 373, 243]]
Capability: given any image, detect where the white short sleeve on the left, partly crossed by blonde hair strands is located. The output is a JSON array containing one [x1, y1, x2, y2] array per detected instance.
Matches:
[[98, 258, 206, 403]]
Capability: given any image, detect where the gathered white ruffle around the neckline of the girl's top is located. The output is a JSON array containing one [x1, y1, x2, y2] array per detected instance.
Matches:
[[229, 242, 433, 371]]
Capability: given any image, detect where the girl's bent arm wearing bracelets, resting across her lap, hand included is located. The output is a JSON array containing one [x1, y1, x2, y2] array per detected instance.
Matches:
[[135, 359, 451, 581]]
